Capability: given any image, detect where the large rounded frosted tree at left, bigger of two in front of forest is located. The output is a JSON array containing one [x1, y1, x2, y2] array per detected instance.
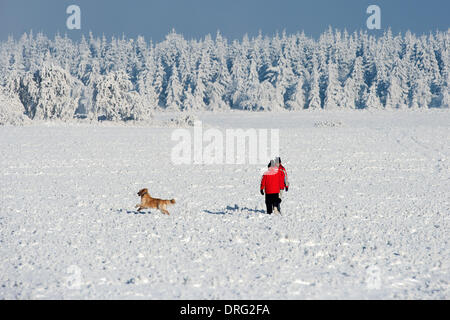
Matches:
[[17, 65, 82, 120]]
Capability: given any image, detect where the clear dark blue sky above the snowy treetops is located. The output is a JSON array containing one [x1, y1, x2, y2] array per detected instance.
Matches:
[[0, 0, 450, 41]]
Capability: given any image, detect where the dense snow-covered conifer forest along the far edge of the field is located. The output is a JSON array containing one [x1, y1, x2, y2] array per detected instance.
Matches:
[[0, 28, 450, 124]]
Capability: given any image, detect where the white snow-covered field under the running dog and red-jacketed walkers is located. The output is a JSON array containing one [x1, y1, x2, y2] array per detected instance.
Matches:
[[0, 110, 450, 299]]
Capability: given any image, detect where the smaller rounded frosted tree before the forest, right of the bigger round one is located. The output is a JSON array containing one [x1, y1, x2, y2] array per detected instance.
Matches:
[[94, 70, 146, 121]]
